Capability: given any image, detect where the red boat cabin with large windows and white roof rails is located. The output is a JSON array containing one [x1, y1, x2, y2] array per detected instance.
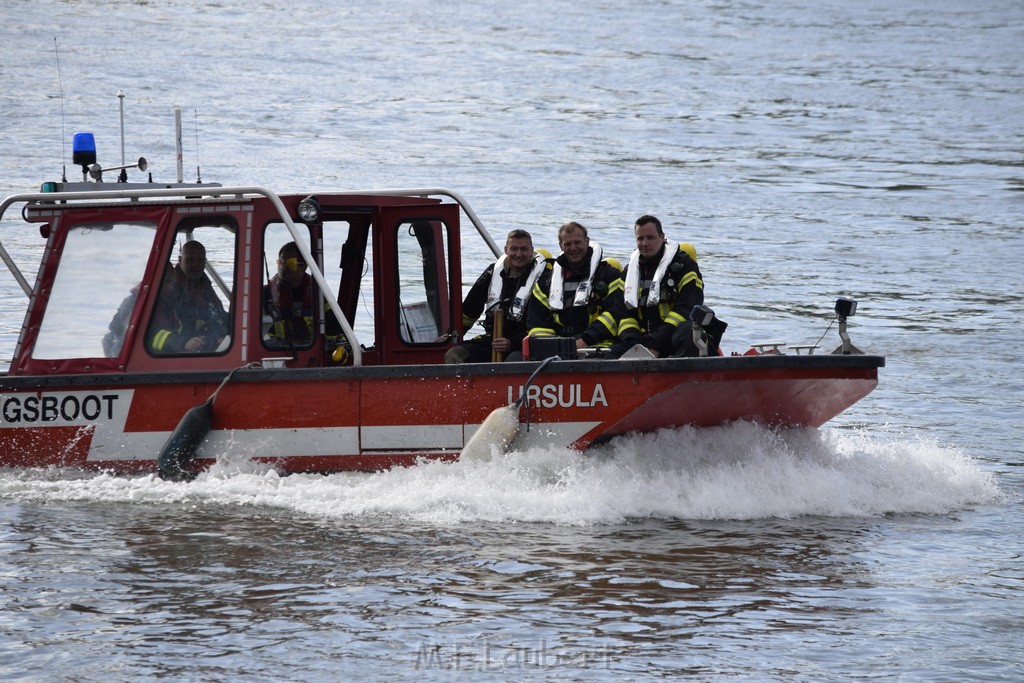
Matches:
[[0, 182, 498, 376]]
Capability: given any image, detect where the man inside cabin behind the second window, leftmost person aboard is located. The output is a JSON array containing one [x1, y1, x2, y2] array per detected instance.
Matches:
[[148, 240, 229, 354]]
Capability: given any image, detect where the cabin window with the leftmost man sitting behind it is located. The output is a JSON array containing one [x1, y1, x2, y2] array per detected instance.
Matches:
[[145, 222, 238, 355]]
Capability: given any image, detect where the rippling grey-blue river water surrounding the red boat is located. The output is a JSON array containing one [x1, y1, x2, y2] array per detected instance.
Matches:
[[0, 0, 1024, 681]]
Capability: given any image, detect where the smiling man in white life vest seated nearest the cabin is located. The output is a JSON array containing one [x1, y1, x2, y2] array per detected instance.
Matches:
[[444, 229, 547, 364]]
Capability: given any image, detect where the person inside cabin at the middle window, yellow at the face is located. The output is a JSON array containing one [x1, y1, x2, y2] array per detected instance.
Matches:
[[263, 242, 314, 347]]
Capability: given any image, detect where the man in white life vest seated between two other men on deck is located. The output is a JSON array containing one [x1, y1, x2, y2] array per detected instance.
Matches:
[[526, 221, 623, 348]]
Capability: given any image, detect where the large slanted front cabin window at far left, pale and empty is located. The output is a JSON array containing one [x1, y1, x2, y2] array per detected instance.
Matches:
[[33, 222, 157, 359]]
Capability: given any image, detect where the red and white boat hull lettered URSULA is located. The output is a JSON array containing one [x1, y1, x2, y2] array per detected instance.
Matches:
[[0, 354, 885, 473]]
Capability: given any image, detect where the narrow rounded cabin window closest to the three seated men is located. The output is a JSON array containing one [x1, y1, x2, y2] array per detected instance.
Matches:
[[396, 220, 452, 344]]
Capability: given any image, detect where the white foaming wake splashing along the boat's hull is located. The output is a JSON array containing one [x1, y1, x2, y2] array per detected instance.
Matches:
[[0, 424, 1005, 525]]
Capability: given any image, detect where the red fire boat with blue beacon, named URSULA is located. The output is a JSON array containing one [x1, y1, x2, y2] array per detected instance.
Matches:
[[0, 122, 885, 476]]
